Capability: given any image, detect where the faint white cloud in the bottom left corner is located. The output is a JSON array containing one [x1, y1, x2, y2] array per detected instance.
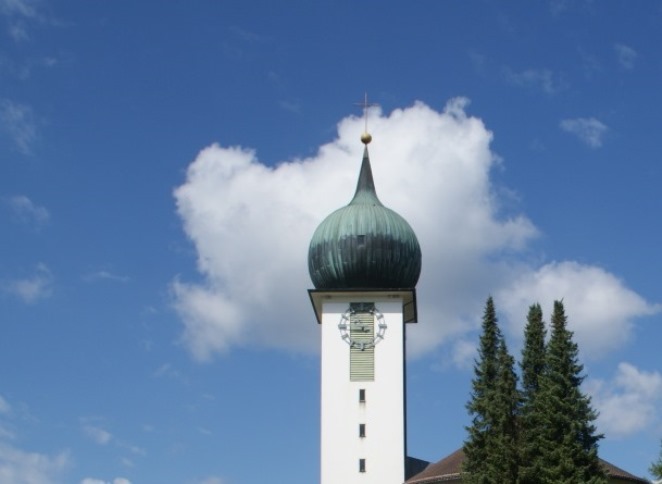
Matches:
[[0, 442, 71, 484]]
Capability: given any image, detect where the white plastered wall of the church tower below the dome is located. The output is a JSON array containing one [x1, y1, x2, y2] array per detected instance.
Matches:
[[321, 291, 406, 484]]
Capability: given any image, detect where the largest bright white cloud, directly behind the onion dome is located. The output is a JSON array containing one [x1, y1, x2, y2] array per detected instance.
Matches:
[[172, 99, 654, 360]]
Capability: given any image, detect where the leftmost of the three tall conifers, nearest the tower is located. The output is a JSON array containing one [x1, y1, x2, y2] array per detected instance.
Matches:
[[463, 297, 519, 484]]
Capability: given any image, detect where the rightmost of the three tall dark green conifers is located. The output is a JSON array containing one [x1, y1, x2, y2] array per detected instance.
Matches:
[[534, 301, 607, 484]]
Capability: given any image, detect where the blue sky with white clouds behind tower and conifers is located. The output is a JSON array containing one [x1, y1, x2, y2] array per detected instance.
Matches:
[[0, 0, 662, 484]]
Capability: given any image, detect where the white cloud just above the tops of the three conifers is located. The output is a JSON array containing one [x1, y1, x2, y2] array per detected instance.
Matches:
[[496, 261, 660, 359]]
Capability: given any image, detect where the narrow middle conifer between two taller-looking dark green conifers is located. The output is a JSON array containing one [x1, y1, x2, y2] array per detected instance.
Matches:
[[518, 304, 546, 484]]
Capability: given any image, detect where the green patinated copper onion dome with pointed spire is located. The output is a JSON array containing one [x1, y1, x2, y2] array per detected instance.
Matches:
[[308, 141, 421, 289]]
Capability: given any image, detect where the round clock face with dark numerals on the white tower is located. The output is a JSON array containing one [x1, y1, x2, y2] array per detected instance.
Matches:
[[338, 303, 386, 350]]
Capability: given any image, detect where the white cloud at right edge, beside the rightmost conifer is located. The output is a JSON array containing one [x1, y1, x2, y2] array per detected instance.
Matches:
[[586, 362, 662, 438]]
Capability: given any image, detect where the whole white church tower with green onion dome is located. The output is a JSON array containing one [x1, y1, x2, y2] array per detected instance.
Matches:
[[308, 126, 421, 484]]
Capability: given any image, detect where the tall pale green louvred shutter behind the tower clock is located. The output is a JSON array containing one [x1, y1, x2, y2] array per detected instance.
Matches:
[[349, 304, 375, 381]]
